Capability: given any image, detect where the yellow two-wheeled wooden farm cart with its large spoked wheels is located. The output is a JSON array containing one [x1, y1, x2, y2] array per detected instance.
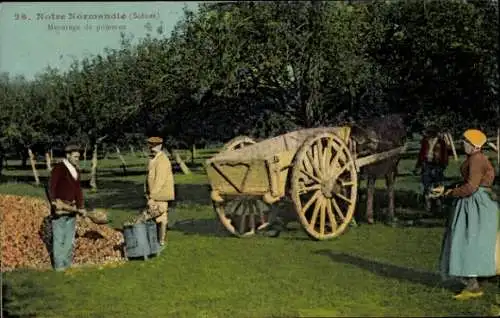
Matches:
[[205, 127, 405, 240]]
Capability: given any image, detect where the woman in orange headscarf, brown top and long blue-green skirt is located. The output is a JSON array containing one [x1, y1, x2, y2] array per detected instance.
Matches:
[[440, 129, 498, 299]]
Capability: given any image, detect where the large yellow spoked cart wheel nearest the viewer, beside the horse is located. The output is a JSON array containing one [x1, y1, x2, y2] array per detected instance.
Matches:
[[290, 132, 358, 240]]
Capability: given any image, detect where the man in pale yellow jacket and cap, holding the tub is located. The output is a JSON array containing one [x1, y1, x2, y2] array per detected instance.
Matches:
[[144, 136, 175, 245]]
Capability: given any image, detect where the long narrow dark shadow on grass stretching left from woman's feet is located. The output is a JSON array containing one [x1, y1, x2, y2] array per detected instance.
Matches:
[[313, 250, 460, 292]]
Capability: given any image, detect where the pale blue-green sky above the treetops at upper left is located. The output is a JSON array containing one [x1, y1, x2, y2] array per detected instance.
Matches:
[[0, 1, 201, 79]]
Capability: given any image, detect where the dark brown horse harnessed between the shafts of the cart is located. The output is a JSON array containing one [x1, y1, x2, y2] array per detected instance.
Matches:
[[351, 114, 407, 224]]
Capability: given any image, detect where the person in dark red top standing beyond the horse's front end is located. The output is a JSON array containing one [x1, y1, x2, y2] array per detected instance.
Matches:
[[413, 125, 448, 213]]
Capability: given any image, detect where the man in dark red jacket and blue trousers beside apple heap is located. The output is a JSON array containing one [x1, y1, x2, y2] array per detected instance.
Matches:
[[49, 145, 86, 271]]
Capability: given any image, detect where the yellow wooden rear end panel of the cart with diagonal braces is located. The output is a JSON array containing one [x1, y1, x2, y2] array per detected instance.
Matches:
[[206, 160, 269, 195]]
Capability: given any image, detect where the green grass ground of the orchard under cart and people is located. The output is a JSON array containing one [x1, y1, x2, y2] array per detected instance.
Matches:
[[0, 143, 499, 317]]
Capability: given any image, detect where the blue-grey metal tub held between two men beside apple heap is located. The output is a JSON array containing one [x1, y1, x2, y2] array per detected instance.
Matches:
[[123, 223, 151, 259]]
